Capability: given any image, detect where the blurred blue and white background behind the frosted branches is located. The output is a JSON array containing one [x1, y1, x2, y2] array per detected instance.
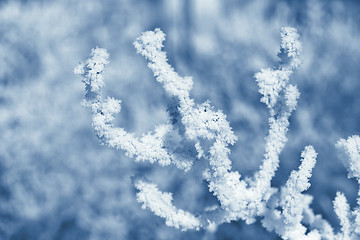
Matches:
[[0, 0, 360, 240]]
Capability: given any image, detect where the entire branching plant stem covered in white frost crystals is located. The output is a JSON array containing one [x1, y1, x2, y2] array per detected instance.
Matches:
[[74, 27, 360, 240]]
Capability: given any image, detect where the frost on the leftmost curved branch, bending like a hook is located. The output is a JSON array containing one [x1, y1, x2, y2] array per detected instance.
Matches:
[[74, 47, 192, 170]]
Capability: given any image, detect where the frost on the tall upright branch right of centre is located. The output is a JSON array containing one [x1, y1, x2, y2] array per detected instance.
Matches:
[[253, 27, 301, 210]]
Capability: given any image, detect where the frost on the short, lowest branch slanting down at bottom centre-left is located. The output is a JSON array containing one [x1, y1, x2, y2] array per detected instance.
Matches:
[[135, 180, 201, 231]]
